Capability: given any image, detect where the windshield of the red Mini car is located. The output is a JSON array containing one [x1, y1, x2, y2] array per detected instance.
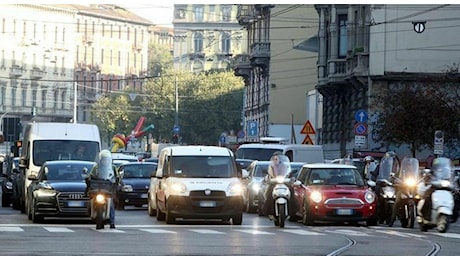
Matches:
[[306, 168, 364, 186]]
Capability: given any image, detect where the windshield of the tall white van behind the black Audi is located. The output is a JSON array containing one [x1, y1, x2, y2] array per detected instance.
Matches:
[[31, 140, 100, 166]]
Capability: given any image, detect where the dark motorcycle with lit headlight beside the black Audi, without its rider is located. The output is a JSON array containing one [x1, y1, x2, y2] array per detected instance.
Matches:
[[88, 179, 113, 229]]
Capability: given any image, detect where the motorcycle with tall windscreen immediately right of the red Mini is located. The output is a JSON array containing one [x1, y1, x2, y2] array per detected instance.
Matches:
[[374, 153, 399, 224]]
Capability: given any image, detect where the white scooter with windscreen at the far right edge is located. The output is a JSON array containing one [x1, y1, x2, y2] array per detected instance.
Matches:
[[417, 157, 454, 233]]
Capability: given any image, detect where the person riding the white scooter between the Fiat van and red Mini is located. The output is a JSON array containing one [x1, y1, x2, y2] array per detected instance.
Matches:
[[263, 152, 297, 219]]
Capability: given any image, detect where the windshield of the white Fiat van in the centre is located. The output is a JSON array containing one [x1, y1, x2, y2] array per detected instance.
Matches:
[[171, 155, 237, 178]]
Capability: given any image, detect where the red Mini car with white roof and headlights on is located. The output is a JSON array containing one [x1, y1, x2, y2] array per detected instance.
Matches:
[[294, 163, 377, 225]]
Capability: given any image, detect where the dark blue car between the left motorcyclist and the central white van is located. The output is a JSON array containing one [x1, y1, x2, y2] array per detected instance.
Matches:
[[115, 162, 158, 210]]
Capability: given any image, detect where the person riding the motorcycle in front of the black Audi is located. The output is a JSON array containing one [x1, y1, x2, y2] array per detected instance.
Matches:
[[86, 150, 120, 228]]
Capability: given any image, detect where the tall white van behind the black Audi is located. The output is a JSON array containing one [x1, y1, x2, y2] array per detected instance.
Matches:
[[19, 122, 101, 214]]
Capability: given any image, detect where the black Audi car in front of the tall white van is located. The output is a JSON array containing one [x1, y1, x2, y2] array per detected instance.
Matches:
[[26, 160, 96, 223]]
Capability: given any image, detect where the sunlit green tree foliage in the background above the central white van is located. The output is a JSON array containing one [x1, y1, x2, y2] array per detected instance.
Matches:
[[92, 42, 244, 145]]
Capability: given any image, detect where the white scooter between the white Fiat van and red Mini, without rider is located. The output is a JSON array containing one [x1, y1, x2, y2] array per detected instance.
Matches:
[[270, 176, 291, 228]]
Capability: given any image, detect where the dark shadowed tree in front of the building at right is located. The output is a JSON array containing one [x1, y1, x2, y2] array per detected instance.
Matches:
[[373, 67, 460, 157]]
